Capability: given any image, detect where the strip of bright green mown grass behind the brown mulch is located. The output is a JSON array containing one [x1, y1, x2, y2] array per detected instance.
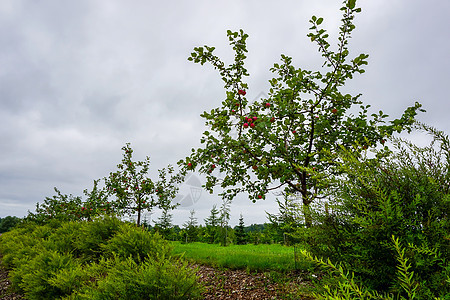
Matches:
[[172, 242, 312, 272]]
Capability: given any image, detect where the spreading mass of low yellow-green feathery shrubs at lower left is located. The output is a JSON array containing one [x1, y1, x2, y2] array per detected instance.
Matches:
[[0, 217, 201, 299]]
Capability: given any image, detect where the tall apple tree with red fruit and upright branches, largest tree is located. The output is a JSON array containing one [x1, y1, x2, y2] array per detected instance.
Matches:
[[179, 0, 421, 226]]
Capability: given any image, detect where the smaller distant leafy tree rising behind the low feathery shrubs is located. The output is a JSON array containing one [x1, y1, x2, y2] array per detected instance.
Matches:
[[105, 144, 183, 225]]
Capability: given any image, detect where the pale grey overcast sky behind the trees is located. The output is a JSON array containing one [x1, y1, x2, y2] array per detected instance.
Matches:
[[0, 0, 450, 224]]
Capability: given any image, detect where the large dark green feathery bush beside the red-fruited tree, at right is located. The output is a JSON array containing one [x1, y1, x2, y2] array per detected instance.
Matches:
[[304, 124, 450, 299]]
